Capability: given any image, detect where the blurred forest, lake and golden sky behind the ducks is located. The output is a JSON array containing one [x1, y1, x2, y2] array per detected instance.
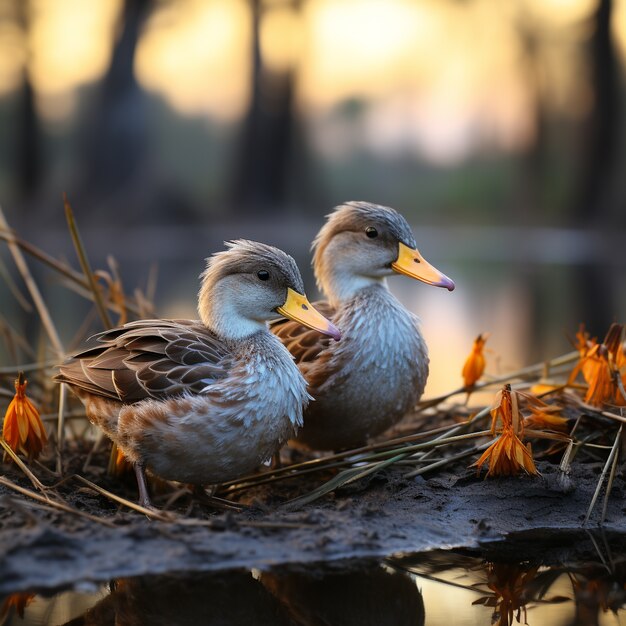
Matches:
[[0, 0, 626, 392]]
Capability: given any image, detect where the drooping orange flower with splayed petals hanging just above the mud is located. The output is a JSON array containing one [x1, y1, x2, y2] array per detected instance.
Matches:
[[472, 385, 541, 476]]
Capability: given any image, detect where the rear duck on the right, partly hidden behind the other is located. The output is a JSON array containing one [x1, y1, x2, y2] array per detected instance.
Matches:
[[271, 201, 455, 450]]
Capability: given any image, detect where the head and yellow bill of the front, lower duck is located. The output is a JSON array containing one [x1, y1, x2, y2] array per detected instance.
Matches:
[[198, 239, 341, 340]]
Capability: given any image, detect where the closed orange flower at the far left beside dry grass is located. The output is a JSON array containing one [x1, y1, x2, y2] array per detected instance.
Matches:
[[2, 372, 48, 458]]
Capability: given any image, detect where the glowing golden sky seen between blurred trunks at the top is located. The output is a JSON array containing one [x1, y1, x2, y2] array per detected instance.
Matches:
[[0, 0, 626, 157]]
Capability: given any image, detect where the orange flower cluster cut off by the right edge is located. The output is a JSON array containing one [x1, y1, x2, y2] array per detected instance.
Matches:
[[568, 324, 626, 406]]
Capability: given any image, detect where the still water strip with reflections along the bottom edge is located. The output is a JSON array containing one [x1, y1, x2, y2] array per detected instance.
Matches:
[[2, 538, 626, 626]]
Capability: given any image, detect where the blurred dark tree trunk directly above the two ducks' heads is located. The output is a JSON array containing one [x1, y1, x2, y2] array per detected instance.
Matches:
[[229, 0, 294, 214]]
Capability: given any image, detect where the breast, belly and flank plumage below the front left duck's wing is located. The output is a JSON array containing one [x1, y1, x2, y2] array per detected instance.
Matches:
[[70, 331, 309, 484]]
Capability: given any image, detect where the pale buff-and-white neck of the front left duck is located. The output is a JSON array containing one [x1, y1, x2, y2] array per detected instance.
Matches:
[[198, 281, 267, 341]]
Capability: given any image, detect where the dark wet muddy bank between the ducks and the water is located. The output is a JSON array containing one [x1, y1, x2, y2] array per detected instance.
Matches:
[[0, 444, 626, 594]]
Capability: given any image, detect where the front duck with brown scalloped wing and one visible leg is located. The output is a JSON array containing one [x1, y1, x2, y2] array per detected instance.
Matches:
[[55, 239, 341, 508]]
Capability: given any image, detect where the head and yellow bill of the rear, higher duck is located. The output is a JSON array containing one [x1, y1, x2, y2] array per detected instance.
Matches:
[[313, 201, 454, 303]]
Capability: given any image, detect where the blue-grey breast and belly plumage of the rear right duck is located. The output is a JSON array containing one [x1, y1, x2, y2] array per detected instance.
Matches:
[[299, 285, 428, 449]]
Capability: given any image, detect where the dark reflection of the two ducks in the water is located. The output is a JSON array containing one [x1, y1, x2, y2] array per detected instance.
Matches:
[[0, 564, 424, 626]]
